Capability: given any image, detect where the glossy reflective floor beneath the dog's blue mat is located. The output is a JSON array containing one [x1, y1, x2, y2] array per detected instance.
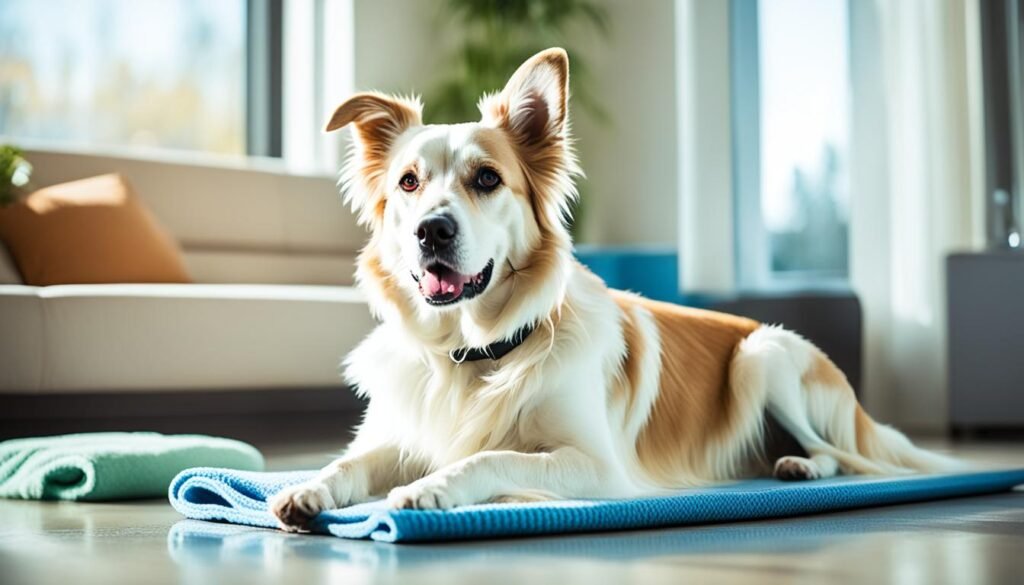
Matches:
[[0, 444, 1024, 585]]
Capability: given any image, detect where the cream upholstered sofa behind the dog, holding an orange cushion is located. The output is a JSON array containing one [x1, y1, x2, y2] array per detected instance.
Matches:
[[0, 145, 374, 395]]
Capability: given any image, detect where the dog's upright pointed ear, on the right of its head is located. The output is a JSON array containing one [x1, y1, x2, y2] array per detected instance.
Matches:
[[480, 48, 569, 144]]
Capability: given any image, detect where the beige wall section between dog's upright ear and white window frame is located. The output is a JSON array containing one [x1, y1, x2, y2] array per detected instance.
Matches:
[[573, 0, 679, 247]]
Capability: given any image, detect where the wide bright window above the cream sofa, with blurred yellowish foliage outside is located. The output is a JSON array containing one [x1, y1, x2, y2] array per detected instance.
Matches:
[[0, 0, 247, 155]]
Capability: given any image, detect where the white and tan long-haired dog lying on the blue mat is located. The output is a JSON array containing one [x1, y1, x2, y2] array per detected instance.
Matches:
[[269, 48, 956, 531]]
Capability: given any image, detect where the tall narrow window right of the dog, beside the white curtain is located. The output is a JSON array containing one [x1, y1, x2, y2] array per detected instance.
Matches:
[[731, 0, 851, 289]]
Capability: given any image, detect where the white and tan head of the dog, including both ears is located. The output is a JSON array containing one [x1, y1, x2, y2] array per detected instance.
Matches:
[[327, 49, 578, 310]]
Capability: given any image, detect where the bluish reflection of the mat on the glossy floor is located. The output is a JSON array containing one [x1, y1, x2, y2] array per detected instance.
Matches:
[[167, 494, 1024, 571]]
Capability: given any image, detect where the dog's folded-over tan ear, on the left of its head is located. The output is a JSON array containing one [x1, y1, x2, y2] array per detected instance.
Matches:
[[327, 92, 423, 224]]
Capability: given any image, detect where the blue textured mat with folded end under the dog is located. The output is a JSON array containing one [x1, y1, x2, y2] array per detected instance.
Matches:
[[169, 467, 1024, 542]]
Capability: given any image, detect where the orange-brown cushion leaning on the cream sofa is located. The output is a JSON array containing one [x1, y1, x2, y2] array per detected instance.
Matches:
[[0, 174, 190, 286]]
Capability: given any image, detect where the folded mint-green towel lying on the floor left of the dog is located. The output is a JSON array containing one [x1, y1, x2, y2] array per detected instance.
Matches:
[[0, 432, 263, 502]]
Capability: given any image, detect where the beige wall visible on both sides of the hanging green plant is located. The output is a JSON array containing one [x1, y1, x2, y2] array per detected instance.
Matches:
[[346, 0, 678, 247]]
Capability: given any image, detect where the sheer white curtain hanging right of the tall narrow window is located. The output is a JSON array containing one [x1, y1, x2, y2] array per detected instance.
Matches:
[[851, 0, 984, 431]]
